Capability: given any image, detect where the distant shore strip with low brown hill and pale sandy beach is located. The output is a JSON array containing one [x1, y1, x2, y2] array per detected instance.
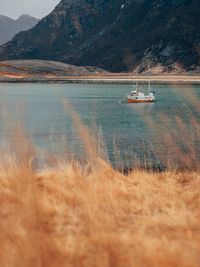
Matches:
[[0, 60, 200, 84]]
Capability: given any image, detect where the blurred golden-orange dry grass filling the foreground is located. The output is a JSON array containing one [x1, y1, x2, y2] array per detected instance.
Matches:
[[0, 157, 200, 267]]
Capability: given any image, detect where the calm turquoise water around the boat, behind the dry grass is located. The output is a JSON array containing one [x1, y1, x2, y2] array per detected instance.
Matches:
[[0, 84, 200, 170]]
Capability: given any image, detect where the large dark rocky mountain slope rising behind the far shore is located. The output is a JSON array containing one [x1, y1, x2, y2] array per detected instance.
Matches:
[[0, 0, 200, 73]]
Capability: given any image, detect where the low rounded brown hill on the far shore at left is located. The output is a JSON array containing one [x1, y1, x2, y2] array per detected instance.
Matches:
[[0, 60, 107, 82]]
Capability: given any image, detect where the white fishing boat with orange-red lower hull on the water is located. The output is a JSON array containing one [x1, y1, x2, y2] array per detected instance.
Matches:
[[127, 82, 156, 103]]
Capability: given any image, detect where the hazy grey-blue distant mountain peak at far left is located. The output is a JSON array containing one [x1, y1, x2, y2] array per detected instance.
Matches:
[[0, 15, 39, 44]]
